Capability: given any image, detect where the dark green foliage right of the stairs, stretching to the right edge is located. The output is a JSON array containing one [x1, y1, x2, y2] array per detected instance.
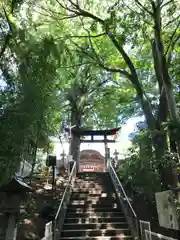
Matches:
[[118, 126, 179, 201]]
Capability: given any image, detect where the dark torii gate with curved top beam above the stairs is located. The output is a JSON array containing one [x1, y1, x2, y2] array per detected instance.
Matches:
[[66, 127, 121, 171]]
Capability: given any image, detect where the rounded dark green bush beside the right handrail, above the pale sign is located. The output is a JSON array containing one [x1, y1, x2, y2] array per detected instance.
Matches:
[[118, 139, 161, 201]]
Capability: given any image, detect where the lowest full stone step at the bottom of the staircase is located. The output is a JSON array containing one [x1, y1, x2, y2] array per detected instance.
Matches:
[[61, 228, 131, 237]]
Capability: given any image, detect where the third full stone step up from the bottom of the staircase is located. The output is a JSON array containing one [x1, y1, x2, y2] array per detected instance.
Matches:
[[64, 216, 126, 224]]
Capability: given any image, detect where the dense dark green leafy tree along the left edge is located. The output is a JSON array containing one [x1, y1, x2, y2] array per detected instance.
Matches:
[[0, 10, 60, 184]]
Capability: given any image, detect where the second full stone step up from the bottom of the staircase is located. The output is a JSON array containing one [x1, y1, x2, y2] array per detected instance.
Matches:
[[63, 222, 128, 230]]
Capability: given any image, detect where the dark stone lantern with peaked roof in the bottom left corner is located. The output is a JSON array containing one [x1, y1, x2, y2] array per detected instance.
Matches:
[[0, 176, 32, 240]]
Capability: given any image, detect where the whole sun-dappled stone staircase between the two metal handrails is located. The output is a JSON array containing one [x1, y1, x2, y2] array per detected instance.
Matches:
[[60, 173, 133, 240]]
